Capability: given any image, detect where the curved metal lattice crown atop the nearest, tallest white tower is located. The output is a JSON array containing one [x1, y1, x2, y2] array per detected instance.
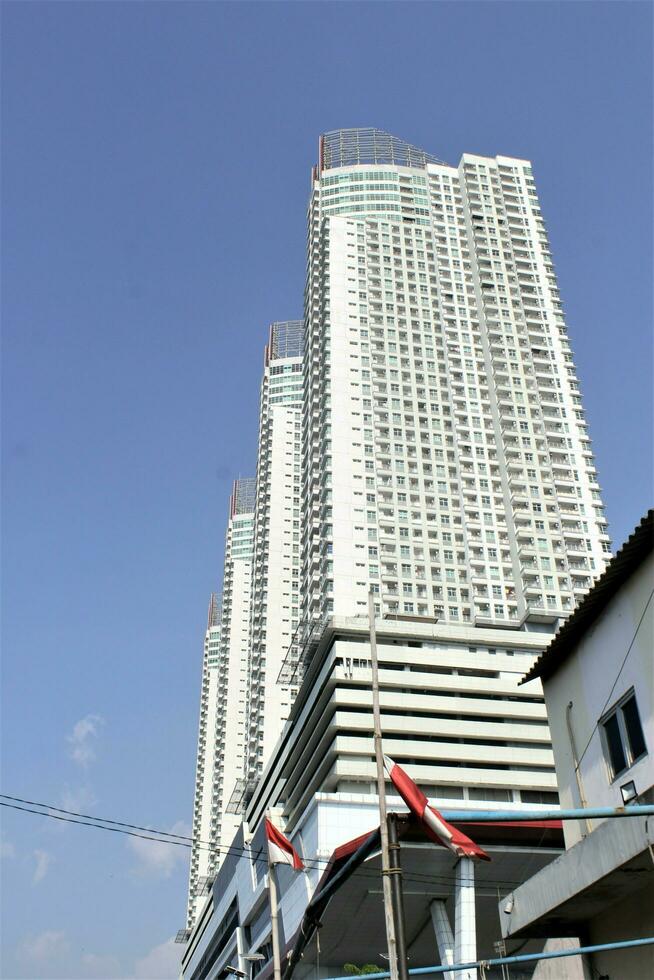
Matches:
[[319, 129, 447, 171]]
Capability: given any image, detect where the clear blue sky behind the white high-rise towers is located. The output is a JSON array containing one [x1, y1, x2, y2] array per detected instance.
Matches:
[[1, 2, 652, 980]]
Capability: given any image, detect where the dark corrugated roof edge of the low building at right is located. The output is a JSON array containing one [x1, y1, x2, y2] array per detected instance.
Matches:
[[520, 509, 654, 684]]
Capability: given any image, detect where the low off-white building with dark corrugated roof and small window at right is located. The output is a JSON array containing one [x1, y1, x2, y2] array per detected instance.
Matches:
[[500, 510, 654, 980]]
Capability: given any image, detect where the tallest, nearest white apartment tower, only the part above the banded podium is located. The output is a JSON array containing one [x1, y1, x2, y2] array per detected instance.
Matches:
[[301, 129, 609, 628]]
